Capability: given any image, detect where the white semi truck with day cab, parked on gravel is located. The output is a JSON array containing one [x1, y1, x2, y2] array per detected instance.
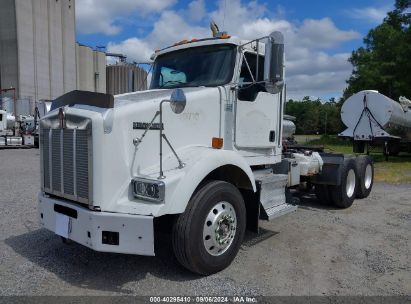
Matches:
[[38, 32, 373, 275]]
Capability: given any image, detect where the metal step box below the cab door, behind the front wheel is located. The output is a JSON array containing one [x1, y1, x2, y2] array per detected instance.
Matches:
[[253, 169, 297, 220]]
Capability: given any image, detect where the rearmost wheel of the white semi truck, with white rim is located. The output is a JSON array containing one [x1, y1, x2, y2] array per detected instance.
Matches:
[[355, 155, 374, 198]]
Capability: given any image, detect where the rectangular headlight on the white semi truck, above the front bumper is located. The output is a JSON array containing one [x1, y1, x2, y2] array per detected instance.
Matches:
[[131, 178, 165, 203]]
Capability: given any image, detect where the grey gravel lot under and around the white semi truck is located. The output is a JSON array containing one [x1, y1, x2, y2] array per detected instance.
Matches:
[[0, 149, 411, 295]]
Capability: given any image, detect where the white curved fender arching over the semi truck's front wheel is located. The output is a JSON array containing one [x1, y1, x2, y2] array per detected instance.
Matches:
[[157, 147, 257, 216]]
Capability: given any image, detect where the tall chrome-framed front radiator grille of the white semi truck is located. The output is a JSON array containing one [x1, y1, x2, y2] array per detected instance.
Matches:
[[40, 128, 92, 205]]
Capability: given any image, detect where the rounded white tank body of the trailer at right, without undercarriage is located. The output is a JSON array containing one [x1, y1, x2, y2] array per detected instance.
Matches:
[[339, 90, 411, 141]]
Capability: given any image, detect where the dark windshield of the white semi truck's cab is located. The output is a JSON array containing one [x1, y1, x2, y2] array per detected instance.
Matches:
[[150, 44, 235, 89]]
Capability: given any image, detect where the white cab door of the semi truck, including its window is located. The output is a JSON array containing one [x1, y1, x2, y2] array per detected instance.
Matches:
[[235, 52, 281, 149]]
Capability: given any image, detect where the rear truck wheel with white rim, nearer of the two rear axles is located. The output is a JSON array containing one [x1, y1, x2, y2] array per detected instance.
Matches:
[[330, 158, 357, 208]]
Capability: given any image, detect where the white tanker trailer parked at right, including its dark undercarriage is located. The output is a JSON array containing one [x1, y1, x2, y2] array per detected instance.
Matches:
[[339, 90, 411, 155]]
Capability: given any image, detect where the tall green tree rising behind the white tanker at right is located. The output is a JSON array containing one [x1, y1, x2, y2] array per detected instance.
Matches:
[[344, 0, 411, 99]]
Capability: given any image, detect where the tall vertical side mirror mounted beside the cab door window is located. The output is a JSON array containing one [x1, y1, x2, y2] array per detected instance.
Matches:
[[264, 31, 284, 93]]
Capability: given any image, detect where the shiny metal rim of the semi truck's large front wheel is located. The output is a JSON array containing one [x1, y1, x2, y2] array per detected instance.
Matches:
[[203, 202, 237, 256]]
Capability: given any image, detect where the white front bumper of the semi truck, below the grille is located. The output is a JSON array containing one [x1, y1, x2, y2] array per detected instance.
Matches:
[[38, 193, 154, 256]]
